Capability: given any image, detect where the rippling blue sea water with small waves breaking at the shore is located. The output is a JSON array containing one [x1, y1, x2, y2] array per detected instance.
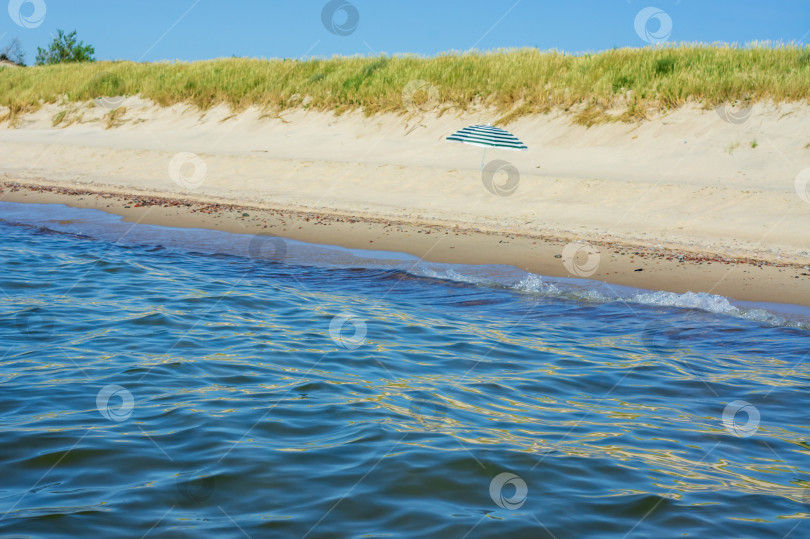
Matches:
[[0, 203, 810, 538]]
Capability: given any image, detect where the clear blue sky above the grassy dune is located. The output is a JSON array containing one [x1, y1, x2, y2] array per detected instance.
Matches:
[[0, 0, 810, 63]]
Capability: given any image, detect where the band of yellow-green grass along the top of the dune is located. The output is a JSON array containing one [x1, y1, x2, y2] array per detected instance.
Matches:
[[0, 45, 810, 125]]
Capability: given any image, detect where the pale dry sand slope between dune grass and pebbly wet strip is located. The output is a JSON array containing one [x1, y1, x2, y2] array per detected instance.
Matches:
[[0, 98, 810, 304]]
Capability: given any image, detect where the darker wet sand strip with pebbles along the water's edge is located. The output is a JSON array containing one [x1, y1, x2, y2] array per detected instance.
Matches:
[[0, 179, 810, 306]]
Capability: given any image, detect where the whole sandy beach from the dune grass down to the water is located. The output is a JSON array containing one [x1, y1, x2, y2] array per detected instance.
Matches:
[[0, 98, 810, 305]]
